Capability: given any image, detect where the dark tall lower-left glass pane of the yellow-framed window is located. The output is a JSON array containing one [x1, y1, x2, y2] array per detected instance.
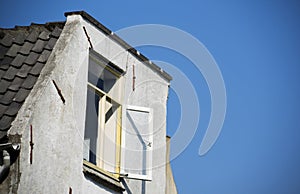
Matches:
[[84, 87, 101, 164]]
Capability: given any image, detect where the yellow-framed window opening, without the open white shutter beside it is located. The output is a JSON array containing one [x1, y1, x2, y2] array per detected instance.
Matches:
[[83, 52, 122, 174]]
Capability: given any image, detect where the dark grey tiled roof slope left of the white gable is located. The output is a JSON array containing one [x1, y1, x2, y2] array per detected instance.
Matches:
[[0, 22, 64, 142]]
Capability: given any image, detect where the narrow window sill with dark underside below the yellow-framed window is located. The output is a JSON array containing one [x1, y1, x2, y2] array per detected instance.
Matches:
[[83, 160, 125, 192]]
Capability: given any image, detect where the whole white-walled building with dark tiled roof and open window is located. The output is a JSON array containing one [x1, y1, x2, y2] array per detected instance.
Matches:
[[0, 11, 177, 194]]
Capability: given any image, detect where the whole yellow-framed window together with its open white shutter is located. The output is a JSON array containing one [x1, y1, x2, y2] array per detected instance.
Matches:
[[83, 50, 153, 180]]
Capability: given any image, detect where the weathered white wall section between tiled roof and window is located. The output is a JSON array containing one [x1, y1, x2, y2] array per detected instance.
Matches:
[[9, 14, 88, 194]]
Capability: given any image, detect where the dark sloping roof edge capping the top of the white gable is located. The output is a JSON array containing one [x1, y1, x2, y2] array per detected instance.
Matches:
[[64, 11, 172, 82]]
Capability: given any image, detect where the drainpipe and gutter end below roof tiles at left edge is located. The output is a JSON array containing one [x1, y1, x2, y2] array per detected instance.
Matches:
[[0, 143, 20, 184]]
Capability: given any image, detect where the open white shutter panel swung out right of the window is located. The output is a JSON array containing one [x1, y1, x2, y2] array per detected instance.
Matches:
[[122, 106, 153, 180]]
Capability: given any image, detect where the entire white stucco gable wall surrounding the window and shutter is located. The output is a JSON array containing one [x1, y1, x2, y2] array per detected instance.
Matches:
[[9, 15, 168, 194]]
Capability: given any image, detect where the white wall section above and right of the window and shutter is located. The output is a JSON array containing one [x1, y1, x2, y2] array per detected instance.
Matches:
[[83, 16, 169, 194]]
